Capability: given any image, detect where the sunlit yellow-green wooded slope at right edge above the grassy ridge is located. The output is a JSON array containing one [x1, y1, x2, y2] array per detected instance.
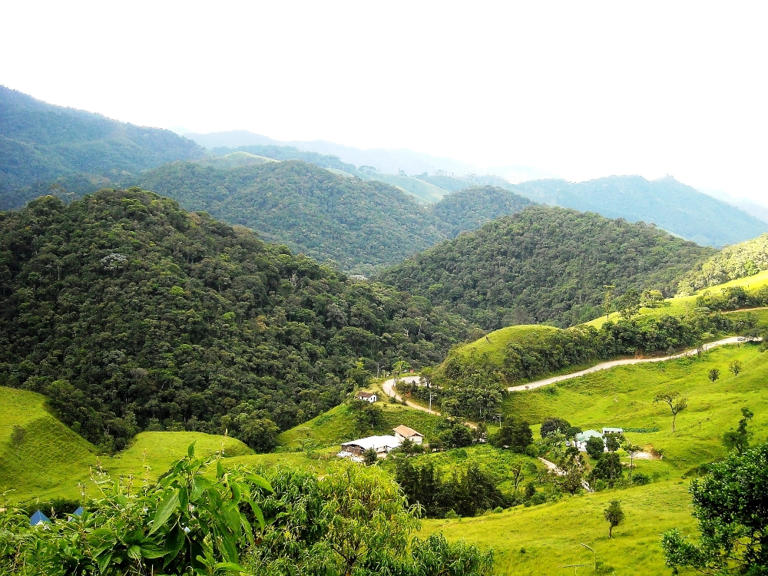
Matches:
[[677, 234, 768, 294]]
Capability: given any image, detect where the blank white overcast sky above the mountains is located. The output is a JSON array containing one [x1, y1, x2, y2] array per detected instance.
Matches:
[[0, 0, 768, 206]]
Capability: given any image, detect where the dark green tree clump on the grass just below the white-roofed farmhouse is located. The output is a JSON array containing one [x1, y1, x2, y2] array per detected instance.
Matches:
[[395, 458, 512, 518]]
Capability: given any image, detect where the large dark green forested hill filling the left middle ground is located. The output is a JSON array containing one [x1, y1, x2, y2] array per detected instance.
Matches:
[[0, 189, 466, 448]]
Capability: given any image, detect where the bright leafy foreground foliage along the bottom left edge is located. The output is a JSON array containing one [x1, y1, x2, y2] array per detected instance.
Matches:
[[0, 448, 492, 576]]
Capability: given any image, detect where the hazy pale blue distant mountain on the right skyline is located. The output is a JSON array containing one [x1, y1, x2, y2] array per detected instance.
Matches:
[[515, 176, 768, 247]]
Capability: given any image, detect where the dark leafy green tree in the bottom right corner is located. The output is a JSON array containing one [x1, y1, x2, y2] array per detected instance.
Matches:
[[662, 443, 768, 575]]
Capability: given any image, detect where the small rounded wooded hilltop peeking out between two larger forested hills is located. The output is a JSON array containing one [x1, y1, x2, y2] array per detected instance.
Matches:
[[432, 186, 532, 238]]
